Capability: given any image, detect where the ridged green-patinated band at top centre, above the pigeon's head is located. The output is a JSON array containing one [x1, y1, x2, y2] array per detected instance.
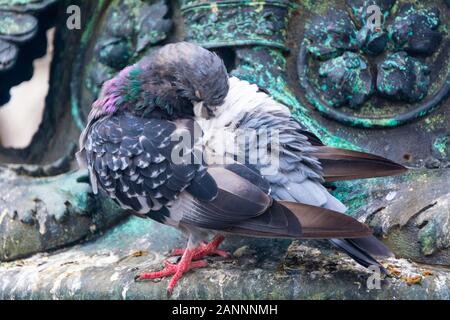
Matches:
[[181, 0, 291, 49]]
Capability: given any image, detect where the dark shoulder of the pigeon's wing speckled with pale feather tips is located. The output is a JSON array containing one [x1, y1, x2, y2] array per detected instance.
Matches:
[[85, 114, 217, 214]]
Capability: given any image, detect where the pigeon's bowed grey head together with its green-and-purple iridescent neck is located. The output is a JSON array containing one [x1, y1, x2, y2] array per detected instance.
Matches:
[[93, 42, 229, 117]]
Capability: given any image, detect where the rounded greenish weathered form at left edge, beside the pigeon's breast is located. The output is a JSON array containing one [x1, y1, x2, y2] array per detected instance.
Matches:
[[0, 169, 123, 261]]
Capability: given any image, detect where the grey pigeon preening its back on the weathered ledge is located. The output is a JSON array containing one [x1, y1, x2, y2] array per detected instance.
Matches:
[[77, 42, 406, 296]]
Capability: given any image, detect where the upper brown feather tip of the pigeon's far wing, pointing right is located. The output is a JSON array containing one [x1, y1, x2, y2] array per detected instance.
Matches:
[[313, 146, 407, 182]]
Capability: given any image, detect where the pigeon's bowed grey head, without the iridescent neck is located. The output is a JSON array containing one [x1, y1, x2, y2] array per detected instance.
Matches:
[[139, 42, 228, 112]]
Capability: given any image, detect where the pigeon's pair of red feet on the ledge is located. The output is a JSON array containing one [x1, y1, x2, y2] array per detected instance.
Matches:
[[135, 236, 229, 297]]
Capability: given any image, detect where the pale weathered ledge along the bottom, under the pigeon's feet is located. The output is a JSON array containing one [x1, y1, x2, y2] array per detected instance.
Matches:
[[0, 217, 450, 299]]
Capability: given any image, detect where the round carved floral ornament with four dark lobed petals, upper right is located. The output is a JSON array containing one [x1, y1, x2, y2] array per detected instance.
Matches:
[[298, 0, 450, 127]]
